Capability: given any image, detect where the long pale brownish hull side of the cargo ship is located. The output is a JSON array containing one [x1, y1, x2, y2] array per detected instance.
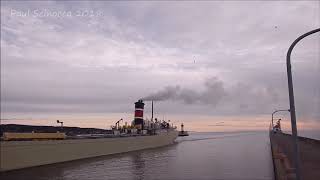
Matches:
[[0, 130, 178, 171]]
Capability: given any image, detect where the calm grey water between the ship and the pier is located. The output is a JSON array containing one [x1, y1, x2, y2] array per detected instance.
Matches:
[[1, 132, 273, 180]]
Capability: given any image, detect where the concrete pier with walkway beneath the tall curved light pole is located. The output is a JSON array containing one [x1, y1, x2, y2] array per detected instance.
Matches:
[[270, 132, 320, 180]]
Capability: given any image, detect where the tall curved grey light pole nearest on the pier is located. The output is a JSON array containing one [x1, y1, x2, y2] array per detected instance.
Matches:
[[287, 28, 320, 180]]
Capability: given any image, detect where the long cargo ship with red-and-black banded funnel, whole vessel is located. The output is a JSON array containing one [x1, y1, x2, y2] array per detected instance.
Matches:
[[0, 100, 178, 171]]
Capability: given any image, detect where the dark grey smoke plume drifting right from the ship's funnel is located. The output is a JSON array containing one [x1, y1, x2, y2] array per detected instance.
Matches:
[[142, 77, 227, 105]]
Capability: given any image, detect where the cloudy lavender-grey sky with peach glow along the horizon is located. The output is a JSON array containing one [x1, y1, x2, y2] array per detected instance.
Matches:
[[1, 1, 320, 131]]
